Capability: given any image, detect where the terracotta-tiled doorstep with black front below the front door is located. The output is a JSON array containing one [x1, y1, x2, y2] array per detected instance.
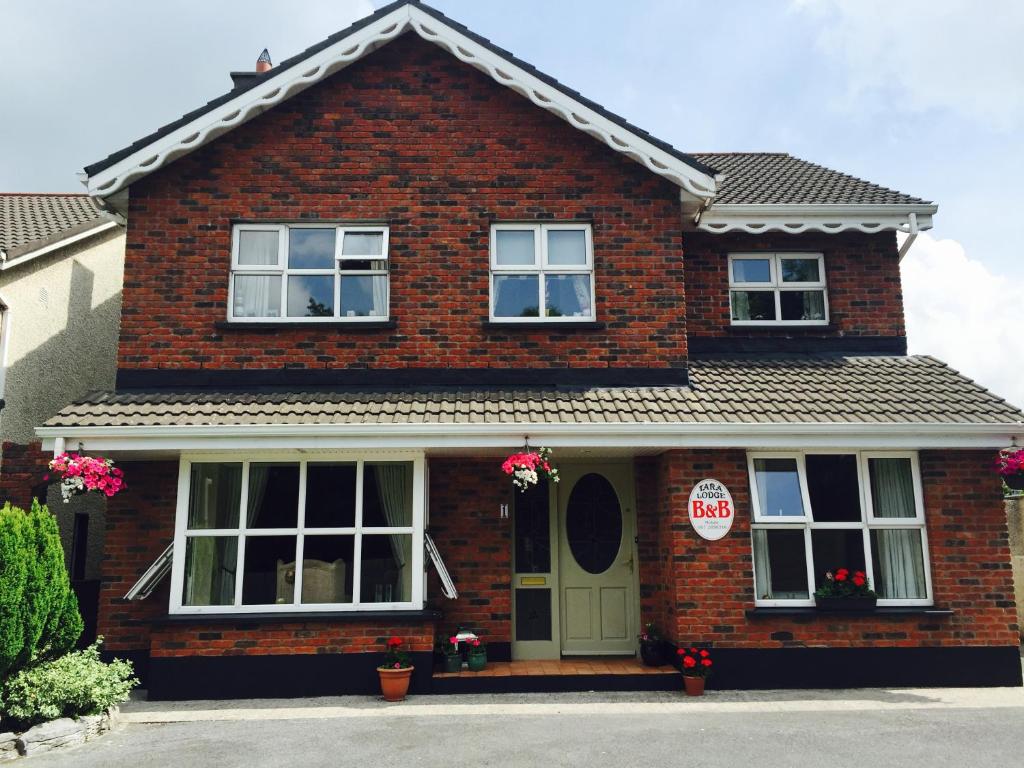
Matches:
[[430, 656, 682, 694]]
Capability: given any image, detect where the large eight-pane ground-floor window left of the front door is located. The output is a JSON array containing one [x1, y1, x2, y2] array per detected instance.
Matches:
[[171, 456, 424, 613]]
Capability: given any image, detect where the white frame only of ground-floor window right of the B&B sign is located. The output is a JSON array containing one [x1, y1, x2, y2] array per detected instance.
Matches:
[[746, 449, 934, 607]]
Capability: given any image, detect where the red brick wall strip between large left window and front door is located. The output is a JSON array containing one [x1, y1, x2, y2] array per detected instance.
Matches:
[[428, 458, 514, 642]]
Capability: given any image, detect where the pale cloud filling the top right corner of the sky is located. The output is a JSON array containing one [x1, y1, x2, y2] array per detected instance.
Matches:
[[793, 0, 1024, 131]]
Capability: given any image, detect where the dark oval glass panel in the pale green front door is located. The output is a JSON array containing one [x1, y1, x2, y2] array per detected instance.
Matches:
[[565, 472, 623, 573]]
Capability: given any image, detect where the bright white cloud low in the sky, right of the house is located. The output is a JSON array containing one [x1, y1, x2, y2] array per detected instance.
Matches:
[[902, 233, 1024, 406]]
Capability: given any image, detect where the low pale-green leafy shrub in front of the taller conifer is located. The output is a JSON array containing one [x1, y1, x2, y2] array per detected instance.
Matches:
[[0, 640, 138, 727]]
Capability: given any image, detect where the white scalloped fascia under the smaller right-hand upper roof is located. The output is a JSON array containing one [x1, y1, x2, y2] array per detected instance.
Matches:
[[696, 204, 938, 234]]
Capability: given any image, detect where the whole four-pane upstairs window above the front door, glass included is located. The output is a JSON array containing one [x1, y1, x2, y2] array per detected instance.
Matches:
[[490, 224, 595, 323]]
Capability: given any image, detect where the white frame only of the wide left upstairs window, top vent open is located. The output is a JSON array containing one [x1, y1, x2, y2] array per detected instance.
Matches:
[[227, 221, 391, 324]]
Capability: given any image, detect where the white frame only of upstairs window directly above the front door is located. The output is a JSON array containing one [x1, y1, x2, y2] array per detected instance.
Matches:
[[487, 221, 597, 324]]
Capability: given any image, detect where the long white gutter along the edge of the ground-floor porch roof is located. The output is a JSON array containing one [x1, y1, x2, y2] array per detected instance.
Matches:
[[36, 422, 1024, 453]]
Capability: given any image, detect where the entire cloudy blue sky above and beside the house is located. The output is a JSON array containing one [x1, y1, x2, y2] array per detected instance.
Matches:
[[0, 0, 1024, 404]]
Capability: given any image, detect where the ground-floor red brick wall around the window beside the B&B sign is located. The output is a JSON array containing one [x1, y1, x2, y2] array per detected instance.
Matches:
[[659, 451, 1018, 648]]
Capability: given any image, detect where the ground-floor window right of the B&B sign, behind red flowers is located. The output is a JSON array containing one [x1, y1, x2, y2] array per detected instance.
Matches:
[[748, 452, 932, 605]]
